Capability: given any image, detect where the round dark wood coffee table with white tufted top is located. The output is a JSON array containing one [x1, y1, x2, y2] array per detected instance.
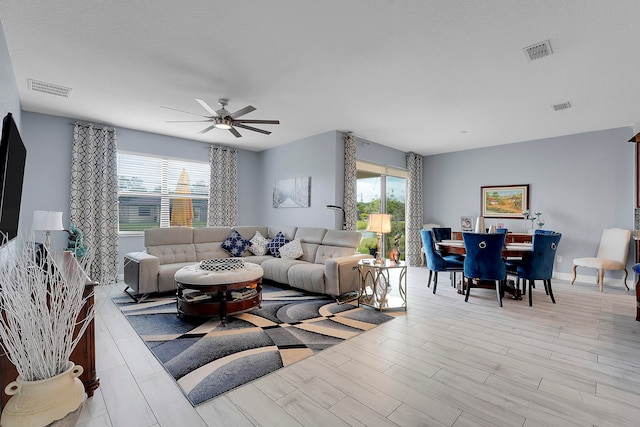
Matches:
[[175, 262, 263, 325]]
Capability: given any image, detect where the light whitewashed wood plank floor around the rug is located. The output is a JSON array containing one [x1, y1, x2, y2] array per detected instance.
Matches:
[[78, 267, 640, 427]]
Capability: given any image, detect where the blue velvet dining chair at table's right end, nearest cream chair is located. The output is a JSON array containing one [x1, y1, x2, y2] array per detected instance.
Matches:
[[507, 230, 562, 306]]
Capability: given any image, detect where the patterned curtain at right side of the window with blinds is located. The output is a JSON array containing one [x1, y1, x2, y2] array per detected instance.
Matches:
[[208, 146, 238, 226]]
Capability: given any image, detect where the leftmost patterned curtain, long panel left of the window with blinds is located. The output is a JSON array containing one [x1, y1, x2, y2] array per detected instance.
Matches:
[[70, 123, 118, 285]]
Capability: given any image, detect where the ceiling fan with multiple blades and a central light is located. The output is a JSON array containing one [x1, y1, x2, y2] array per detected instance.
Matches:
[[163, 98, 280, 138]]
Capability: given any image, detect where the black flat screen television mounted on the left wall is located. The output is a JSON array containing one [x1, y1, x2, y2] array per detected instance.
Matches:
[[0, 113, 27, 241]]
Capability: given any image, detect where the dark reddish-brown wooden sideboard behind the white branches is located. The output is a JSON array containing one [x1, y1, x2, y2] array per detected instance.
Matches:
[[0, 253, 100, 409]]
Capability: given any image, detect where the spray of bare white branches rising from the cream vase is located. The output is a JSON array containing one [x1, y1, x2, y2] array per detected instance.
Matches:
[[0, 239, 94, 381]]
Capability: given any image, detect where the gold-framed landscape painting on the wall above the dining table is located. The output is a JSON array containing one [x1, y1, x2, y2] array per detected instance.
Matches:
[[480, 184, 529, 219]]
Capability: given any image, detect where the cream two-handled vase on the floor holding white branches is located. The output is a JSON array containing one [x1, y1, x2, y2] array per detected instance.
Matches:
[[0, 362, 84, 427]]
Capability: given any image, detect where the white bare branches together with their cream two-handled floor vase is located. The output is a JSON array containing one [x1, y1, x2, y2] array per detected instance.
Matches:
[[0, 239, 94, 427]]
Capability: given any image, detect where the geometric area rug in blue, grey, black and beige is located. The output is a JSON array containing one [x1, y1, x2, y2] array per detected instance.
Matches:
[[113, 284, 393, 406]]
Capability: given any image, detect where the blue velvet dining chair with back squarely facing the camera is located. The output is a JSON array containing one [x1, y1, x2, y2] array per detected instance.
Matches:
[[462, 233, 507, 307]]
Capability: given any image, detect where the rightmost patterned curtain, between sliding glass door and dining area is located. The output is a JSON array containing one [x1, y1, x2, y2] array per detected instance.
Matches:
[[405, 153, 422, 265]]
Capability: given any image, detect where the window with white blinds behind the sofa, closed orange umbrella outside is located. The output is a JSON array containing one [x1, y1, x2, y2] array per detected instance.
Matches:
[[118, 151, 210, 232]]
